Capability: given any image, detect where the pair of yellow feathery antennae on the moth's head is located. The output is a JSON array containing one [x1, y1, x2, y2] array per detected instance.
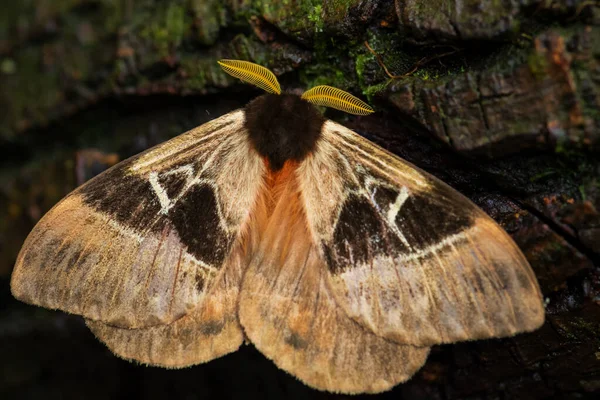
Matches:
[[218, 60, 374, 115]]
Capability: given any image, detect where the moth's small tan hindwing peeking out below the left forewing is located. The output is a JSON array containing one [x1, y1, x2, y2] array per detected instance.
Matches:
[[86, 248, 247, 368]]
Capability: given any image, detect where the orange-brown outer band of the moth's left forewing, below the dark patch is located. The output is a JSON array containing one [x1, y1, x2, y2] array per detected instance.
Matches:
[[12, 195, 215, 326]]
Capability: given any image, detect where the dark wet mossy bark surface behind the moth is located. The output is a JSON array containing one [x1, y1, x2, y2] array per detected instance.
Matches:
[[0, 0, 600, 399]]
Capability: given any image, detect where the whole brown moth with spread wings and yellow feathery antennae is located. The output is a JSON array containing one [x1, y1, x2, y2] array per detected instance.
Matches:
[[11, 60, 544, 393]]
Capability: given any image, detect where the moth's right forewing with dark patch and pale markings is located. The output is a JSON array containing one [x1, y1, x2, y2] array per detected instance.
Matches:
[[298, 121, 544, 346]]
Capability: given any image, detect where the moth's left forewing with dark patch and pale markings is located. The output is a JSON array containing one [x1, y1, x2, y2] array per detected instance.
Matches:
[[11, 111, 264, 328]]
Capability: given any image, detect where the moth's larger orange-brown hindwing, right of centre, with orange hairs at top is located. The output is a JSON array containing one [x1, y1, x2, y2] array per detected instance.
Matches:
[[239, 166, 429, 393]]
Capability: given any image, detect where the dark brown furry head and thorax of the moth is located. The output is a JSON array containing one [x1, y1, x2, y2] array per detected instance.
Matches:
[[245, 94, 325, 171]]
